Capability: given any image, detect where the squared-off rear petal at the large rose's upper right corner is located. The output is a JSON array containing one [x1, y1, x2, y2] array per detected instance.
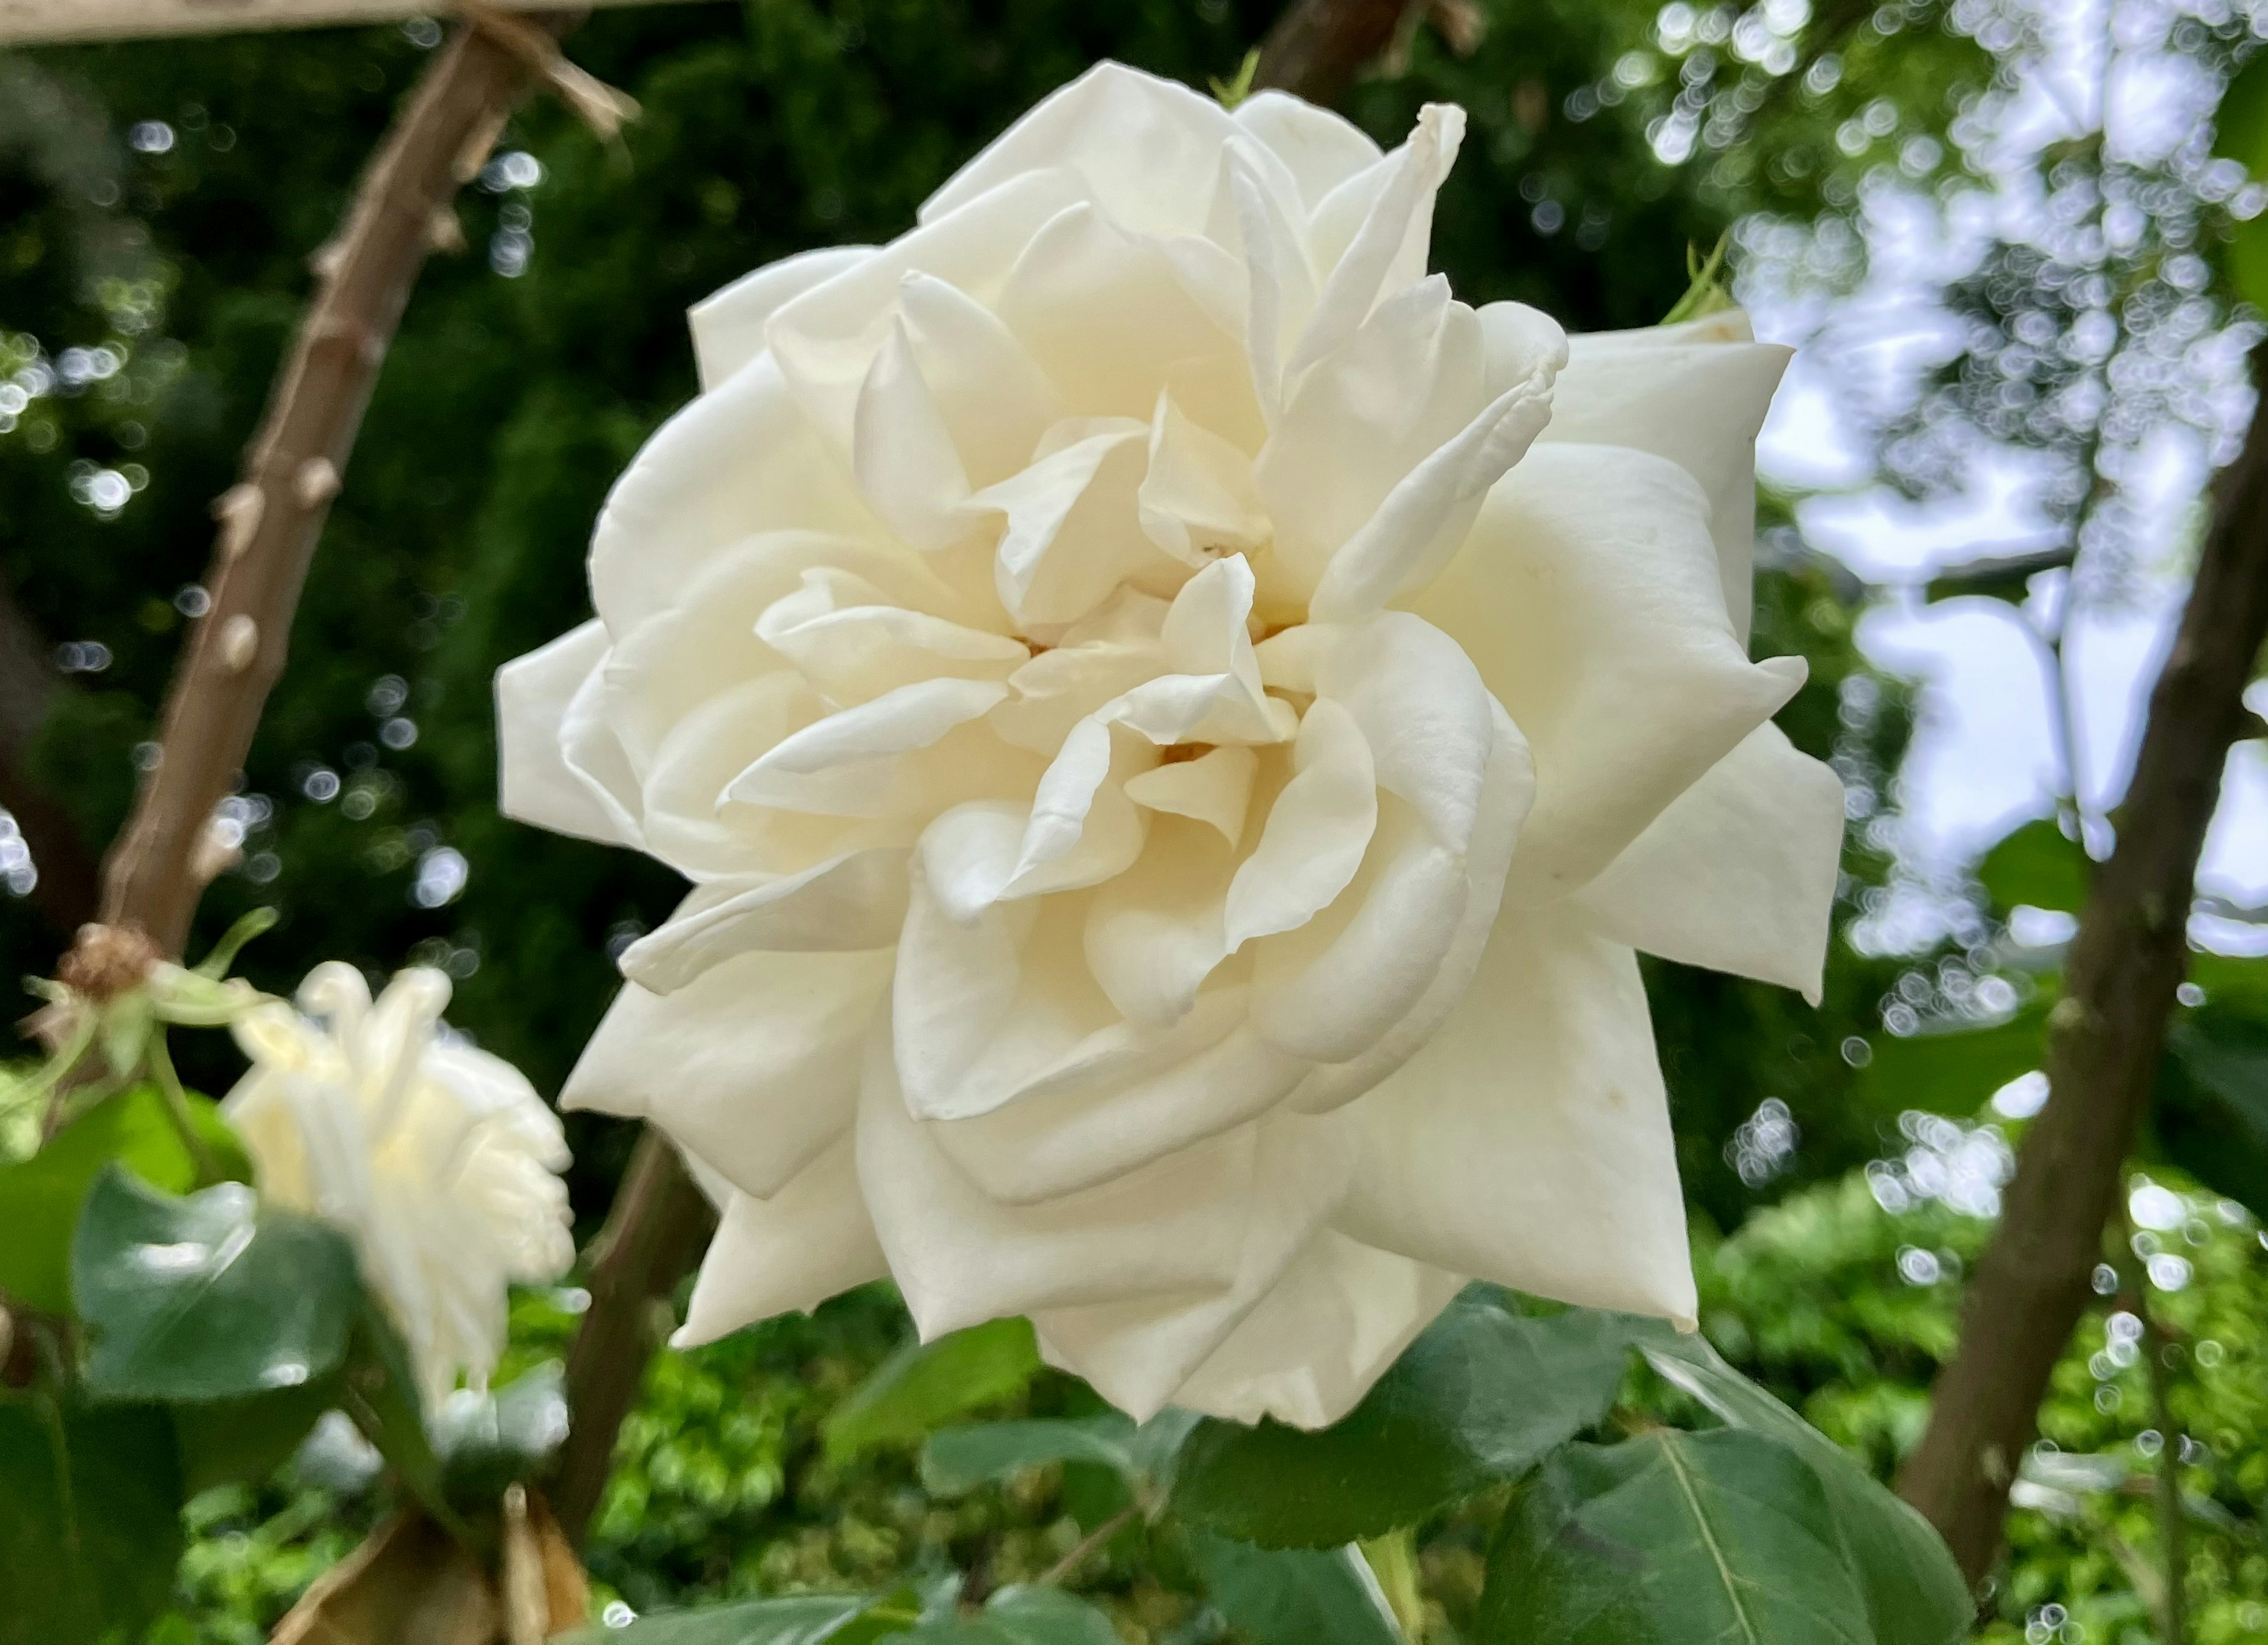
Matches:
[[1540, 318, 1794, 642]]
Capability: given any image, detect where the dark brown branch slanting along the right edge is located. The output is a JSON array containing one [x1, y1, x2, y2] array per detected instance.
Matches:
[[1898, 345, 2268, 1581]]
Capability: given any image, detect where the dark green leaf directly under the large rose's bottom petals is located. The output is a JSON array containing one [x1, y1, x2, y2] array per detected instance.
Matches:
[[1172, 1298, 1651, 1548]]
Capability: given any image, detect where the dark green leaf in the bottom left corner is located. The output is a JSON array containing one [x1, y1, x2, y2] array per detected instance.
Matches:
[[0, 1398, 181, 1645]]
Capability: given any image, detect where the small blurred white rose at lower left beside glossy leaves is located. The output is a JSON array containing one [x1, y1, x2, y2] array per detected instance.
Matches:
[[220, 960, 574, 1400]]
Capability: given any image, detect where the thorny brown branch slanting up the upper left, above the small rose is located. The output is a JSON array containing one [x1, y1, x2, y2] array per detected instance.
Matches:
[[88, 14, 567, 953]]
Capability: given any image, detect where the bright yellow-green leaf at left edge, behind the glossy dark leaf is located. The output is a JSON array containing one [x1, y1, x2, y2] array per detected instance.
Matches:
[[0, 1084, 252, 1314]]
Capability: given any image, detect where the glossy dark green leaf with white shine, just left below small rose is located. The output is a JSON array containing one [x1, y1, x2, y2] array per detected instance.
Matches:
[[70, 1168, 363, 1400]]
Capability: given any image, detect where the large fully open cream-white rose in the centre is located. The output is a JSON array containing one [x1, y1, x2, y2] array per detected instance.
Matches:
[[499, 64, 1842, 1425]]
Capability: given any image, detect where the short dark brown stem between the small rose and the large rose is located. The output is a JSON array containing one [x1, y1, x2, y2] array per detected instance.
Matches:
[[549, 1125, 716, 1548]]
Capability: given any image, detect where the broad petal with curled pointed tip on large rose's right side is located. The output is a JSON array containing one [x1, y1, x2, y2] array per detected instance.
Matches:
[[1410, 445, 1803, 903]]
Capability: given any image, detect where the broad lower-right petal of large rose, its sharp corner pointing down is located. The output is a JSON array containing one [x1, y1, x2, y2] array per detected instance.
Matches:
[[1336, 905, 1694, 1321]]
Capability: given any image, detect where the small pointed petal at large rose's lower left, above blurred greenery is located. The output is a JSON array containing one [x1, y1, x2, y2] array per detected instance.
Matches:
[[669, 1132, 889, 1348]]
